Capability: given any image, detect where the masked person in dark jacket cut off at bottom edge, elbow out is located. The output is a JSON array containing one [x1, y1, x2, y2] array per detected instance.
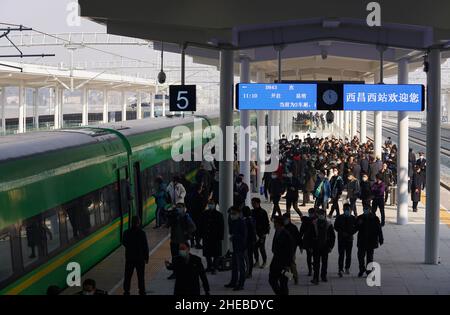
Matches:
[[165, 243, 209, 296]]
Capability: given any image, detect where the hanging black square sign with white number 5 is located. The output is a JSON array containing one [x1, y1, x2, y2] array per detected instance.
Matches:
[[169, 85, 197, 112]]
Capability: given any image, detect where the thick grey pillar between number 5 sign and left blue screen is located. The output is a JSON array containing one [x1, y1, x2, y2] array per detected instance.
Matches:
[[219, 49, 234, 253]]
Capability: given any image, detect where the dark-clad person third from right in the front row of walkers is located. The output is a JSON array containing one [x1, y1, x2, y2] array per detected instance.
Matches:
[[310, 209, 336, 284]]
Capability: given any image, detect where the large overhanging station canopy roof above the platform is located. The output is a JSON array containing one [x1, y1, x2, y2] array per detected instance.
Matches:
[[78, 0, 450, 80]]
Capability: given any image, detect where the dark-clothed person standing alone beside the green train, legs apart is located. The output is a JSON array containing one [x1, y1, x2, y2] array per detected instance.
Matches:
[[122, 216, 149, 295]]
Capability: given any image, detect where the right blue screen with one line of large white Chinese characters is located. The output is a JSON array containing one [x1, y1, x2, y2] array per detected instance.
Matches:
[[344, 84, 425, 112]]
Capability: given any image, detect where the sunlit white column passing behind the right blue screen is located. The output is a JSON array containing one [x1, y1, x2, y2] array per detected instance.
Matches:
[[397, 59, 409, 225]]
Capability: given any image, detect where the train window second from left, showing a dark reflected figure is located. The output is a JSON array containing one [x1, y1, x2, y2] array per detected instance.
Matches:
[[20, 217, 43, 267]]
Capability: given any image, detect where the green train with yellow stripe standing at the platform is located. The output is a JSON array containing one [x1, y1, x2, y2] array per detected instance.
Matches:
[[0, 116, 218, 295]]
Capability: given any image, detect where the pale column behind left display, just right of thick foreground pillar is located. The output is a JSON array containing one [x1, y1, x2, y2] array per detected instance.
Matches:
[[239, 56, 252, 206]]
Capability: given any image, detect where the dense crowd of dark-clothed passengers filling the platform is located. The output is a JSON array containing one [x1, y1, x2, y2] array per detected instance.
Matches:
[[52, 134, 426, 295]]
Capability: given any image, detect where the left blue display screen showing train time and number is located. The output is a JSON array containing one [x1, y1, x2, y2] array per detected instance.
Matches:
[[236, 83, 317, 110]]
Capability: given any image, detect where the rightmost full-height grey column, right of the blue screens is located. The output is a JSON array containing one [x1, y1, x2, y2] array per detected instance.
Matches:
[[425, 48, 441, 265]]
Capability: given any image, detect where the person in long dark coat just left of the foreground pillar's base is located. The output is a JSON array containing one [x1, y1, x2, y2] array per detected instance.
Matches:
[[199, 199, 224, 275]]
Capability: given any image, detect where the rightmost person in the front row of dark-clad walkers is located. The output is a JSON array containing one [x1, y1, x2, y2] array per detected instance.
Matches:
[[356, 208, 384, 277]]
